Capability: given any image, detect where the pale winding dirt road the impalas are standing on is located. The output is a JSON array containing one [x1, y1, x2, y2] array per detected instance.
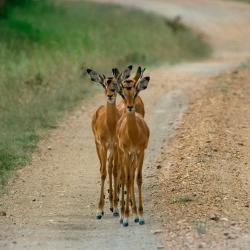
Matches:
[[0, 0, 250, 249]]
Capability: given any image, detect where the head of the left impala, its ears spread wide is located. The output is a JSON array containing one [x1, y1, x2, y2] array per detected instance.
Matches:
[[87, 65, 132, 103]]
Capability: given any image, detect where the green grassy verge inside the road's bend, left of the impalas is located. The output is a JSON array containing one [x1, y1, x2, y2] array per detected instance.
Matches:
[[0, 1, 210, 186]]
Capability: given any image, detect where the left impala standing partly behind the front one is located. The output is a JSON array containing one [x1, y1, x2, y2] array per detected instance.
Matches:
[[87, 65, 136, 219]]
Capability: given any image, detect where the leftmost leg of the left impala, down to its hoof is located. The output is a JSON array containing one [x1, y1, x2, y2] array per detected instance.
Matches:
[[96, 145, 107, 219]]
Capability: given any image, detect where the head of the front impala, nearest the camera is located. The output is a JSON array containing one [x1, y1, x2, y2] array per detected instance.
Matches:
[[117, 67, 150, 113]]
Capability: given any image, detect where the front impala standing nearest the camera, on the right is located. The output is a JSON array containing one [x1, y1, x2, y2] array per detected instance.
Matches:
[[116, 67, 150, 227]]
